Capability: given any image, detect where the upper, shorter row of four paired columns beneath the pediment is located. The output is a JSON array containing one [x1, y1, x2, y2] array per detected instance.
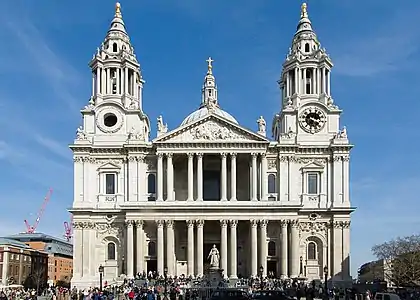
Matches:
[[156, 153, 268, 201]]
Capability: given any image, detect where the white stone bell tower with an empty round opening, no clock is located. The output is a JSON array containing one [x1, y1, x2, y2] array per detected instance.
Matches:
[[75, 2, 150, 145]]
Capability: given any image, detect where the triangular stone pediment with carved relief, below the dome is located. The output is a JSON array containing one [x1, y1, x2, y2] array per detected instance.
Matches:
[[153, 115, 269, 143]]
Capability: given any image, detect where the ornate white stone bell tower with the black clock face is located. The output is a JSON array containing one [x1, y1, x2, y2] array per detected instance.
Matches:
[[272, 3, 341, 143]]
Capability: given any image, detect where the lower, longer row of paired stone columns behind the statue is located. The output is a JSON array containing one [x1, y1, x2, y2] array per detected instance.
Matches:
[[126, 219, 299, 278]]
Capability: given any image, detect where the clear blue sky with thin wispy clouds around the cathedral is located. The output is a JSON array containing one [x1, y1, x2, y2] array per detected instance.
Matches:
[[0, 0, 420, 274]]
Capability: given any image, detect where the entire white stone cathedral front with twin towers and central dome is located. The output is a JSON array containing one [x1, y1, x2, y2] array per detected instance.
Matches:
[[70, 4, 354, 288]]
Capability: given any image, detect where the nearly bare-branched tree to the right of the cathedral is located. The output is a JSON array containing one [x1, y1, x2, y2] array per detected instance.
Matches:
[[372, 235, 420, 287]]
